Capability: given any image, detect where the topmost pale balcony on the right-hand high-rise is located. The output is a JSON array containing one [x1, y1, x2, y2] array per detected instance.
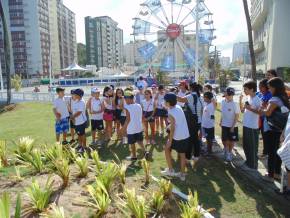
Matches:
[[251, 0, 270, 29]]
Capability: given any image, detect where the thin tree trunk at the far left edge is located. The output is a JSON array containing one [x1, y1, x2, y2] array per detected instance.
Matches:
[[0, 0, 11, 105]]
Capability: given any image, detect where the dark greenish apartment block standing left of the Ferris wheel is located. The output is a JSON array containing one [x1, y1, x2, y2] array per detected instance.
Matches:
[[85, 16, 124, 68]]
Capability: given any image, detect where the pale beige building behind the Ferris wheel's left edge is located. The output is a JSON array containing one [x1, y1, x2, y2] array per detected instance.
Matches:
[[124, 40, 148, 66]]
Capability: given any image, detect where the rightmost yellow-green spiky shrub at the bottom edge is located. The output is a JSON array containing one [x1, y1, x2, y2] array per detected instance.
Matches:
[[179, 191, 207, 218]]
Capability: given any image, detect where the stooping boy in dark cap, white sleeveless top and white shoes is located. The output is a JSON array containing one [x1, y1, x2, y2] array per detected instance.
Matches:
[[161, 93, 190, 181]]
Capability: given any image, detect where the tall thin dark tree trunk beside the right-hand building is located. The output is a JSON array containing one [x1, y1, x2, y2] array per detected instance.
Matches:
[[243, 0, 257, 81]]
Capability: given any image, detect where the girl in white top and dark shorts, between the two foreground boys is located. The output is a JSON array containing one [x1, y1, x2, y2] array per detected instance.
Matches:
[[141, 89, 156, 145]]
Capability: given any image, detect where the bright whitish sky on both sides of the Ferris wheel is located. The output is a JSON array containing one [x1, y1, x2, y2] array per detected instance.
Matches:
[[63, 0, 247, 57]]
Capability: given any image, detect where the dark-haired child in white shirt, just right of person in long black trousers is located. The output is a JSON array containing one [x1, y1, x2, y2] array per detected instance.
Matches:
[[201, 92, 215, 154]]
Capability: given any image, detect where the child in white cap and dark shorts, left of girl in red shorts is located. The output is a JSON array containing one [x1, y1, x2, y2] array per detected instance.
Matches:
[[87, 88, 104, 146]]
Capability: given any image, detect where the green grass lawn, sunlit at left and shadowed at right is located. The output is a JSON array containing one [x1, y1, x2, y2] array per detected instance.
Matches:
[[0, 103, 290, 217]]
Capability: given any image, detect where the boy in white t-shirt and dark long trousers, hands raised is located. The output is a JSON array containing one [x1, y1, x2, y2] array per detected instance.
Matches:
[[240, 81, 262, 169]]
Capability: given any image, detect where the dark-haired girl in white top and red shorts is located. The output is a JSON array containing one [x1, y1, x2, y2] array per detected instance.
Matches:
[[103, 86, 114, 141]]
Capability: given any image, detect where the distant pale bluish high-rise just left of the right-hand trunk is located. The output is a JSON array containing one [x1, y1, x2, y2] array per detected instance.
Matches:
[[232, 42, 251, 65]]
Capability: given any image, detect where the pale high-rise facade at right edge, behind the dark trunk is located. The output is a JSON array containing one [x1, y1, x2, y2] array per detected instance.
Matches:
[[251, 0, 290, 72]]
